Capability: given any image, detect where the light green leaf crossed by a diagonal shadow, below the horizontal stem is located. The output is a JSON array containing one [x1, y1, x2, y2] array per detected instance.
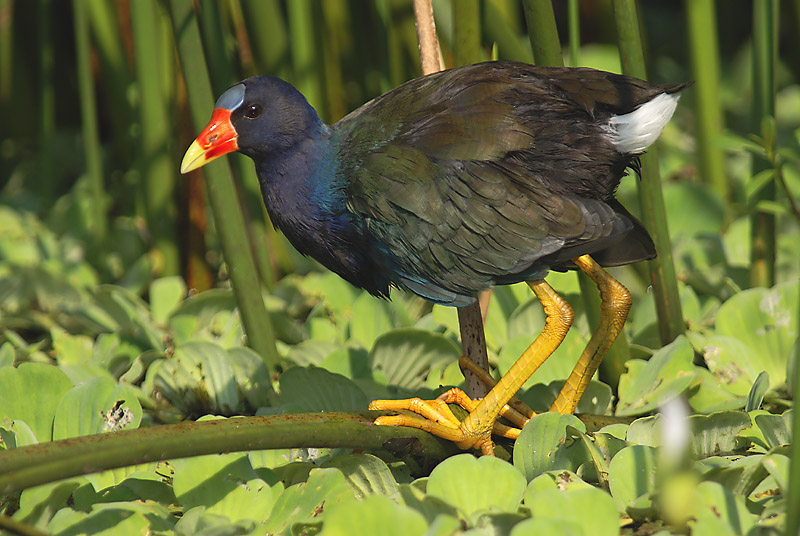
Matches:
[[171, 454, 282, 523]]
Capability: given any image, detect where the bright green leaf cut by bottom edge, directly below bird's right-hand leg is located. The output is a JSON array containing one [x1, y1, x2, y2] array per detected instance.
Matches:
[[525, 488, 619, 536]]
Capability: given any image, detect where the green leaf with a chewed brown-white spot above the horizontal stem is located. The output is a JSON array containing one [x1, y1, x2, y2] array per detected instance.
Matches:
[[53, 376, 142, 440]]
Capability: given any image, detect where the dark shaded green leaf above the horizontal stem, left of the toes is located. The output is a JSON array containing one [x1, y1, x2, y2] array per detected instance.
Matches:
[[280, 367, 368, 411]]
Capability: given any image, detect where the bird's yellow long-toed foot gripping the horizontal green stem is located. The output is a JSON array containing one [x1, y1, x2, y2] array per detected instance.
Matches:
[[369, 388, 527, 456]]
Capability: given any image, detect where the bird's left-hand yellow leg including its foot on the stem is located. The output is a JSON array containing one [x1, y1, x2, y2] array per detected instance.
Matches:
[[370, 279, 573, 455]]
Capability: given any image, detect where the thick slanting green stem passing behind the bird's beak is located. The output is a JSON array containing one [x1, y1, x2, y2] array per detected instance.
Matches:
[[170, 0, 279, 373]]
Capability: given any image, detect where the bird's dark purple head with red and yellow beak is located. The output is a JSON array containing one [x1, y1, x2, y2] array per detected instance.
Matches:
[[181, 76, 323, 173]]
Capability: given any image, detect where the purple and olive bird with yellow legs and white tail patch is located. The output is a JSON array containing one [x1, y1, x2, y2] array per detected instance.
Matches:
[[181, 61, 689, 455]]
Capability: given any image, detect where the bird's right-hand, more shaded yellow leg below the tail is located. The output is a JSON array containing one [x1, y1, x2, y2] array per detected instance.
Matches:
[[550, 255, 631, 414]]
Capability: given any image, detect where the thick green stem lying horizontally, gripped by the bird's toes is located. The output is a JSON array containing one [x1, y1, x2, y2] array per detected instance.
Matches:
[[0, 412, 455, 495]]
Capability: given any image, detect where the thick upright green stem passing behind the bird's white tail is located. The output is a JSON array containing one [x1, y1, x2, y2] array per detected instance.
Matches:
[[613, 0, 685, 344]]
